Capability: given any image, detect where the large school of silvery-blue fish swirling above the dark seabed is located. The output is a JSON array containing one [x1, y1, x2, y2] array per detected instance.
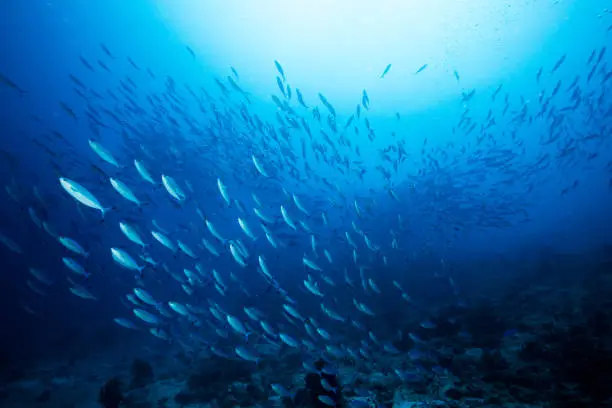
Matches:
[[0, 11, 612, 406]]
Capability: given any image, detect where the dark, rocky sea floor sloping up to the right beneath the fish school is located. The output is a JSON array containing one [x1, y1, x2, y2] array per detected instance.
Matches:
[[0, 248, 612, 408]]
